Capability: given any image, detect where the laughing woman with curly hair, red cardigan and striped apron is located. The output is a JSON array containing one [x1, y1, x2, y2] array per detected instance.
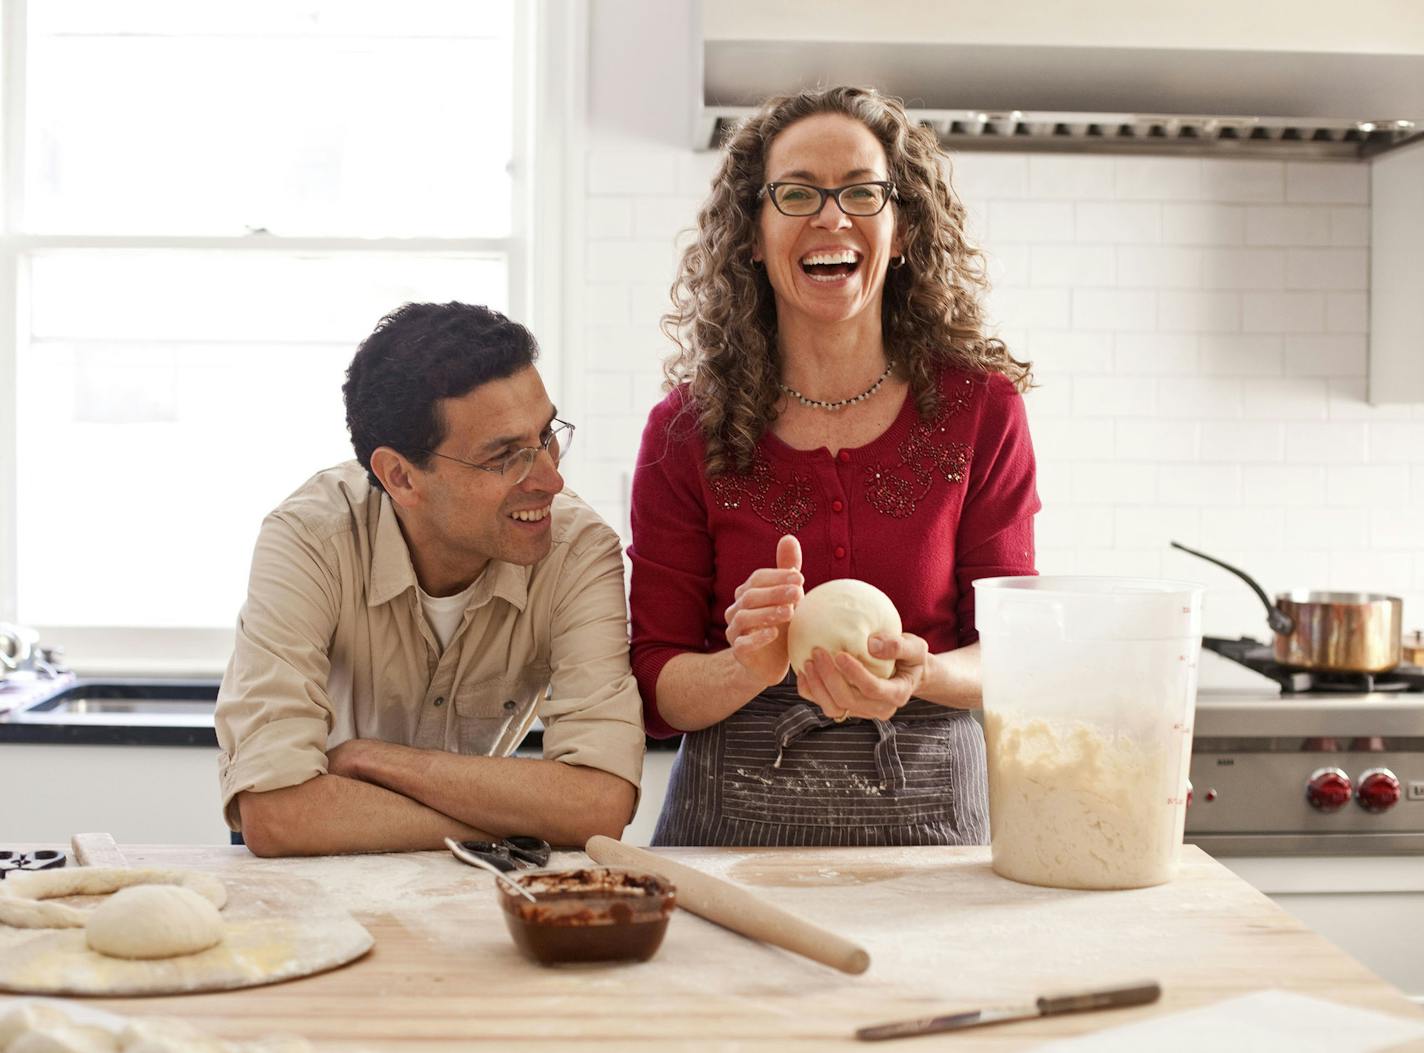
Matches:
[[629, 87, 1038, 845]]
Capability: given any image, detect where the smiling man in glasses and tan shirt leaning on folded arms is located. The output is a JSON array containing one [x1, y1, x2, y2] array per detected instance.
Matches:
[[216, 304, 644, 855]]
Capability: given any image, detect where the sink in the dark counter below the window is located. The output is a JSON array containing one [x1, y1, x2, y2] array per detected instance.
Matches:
[[6, 678, 219, 728]]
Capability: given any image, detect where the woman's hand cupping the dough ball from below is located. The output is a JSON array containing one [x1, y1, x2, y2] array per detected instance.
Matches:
[[796, 633, 930, 720]]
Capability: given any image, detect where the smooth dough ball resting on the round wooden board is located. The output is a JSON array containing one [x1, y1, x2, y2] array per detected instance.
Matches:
[[84, 885, 224, 958]]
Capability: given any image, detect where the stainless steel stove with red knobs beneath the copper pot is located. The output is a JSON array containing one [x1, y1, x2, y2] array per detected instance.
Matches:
[[1186, 637, 1424, 855]]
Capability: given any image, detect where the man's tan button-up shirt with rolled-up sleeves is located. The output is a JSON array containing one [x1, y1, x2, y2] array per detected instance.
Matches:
[[216, 460, 644, 829]]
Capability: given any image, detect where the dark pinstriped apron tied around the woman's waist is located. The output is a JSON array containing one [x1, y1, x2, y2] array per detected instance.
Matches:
[[652, 677, 988, 846]]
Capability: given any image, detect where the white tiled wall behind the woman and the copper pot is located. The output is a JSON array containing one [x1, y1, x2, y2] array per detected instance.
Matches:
[[570, 0, 1424, 636]]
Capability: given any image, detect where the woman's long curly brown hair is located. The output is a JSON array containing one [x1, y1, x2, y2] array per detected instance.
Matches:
[[662, 87, 1031, 477]]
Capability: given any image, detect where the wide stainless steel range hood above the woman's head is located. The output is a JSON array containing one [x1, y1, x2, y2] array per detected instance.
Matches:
[[696, 0, 1424, 158]]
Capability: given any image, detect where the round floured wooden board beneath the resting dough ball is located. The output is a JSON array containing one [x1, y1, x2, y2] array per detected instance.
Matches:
[[0, 873, 375, 996]]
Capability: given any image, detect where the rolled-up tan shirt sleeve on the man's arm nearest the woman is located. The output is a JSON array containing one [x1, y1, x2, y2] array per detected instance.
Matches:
[[538, 523, 645, 788]]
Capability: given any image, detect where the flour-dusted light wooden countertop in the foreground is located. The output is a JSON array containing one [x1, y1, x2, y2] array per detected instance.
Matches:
[[2, 845, 1424, 1053]]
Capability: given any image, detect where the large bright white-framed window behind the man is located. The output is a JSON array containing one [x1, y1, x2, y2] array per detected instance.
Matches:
[[0, 0, 547, 660]]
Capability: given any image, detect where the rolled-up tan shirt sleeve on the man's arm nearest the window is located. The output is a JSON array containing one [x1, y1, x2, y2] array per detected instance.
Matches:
[[214, 514, 340, 829]]
